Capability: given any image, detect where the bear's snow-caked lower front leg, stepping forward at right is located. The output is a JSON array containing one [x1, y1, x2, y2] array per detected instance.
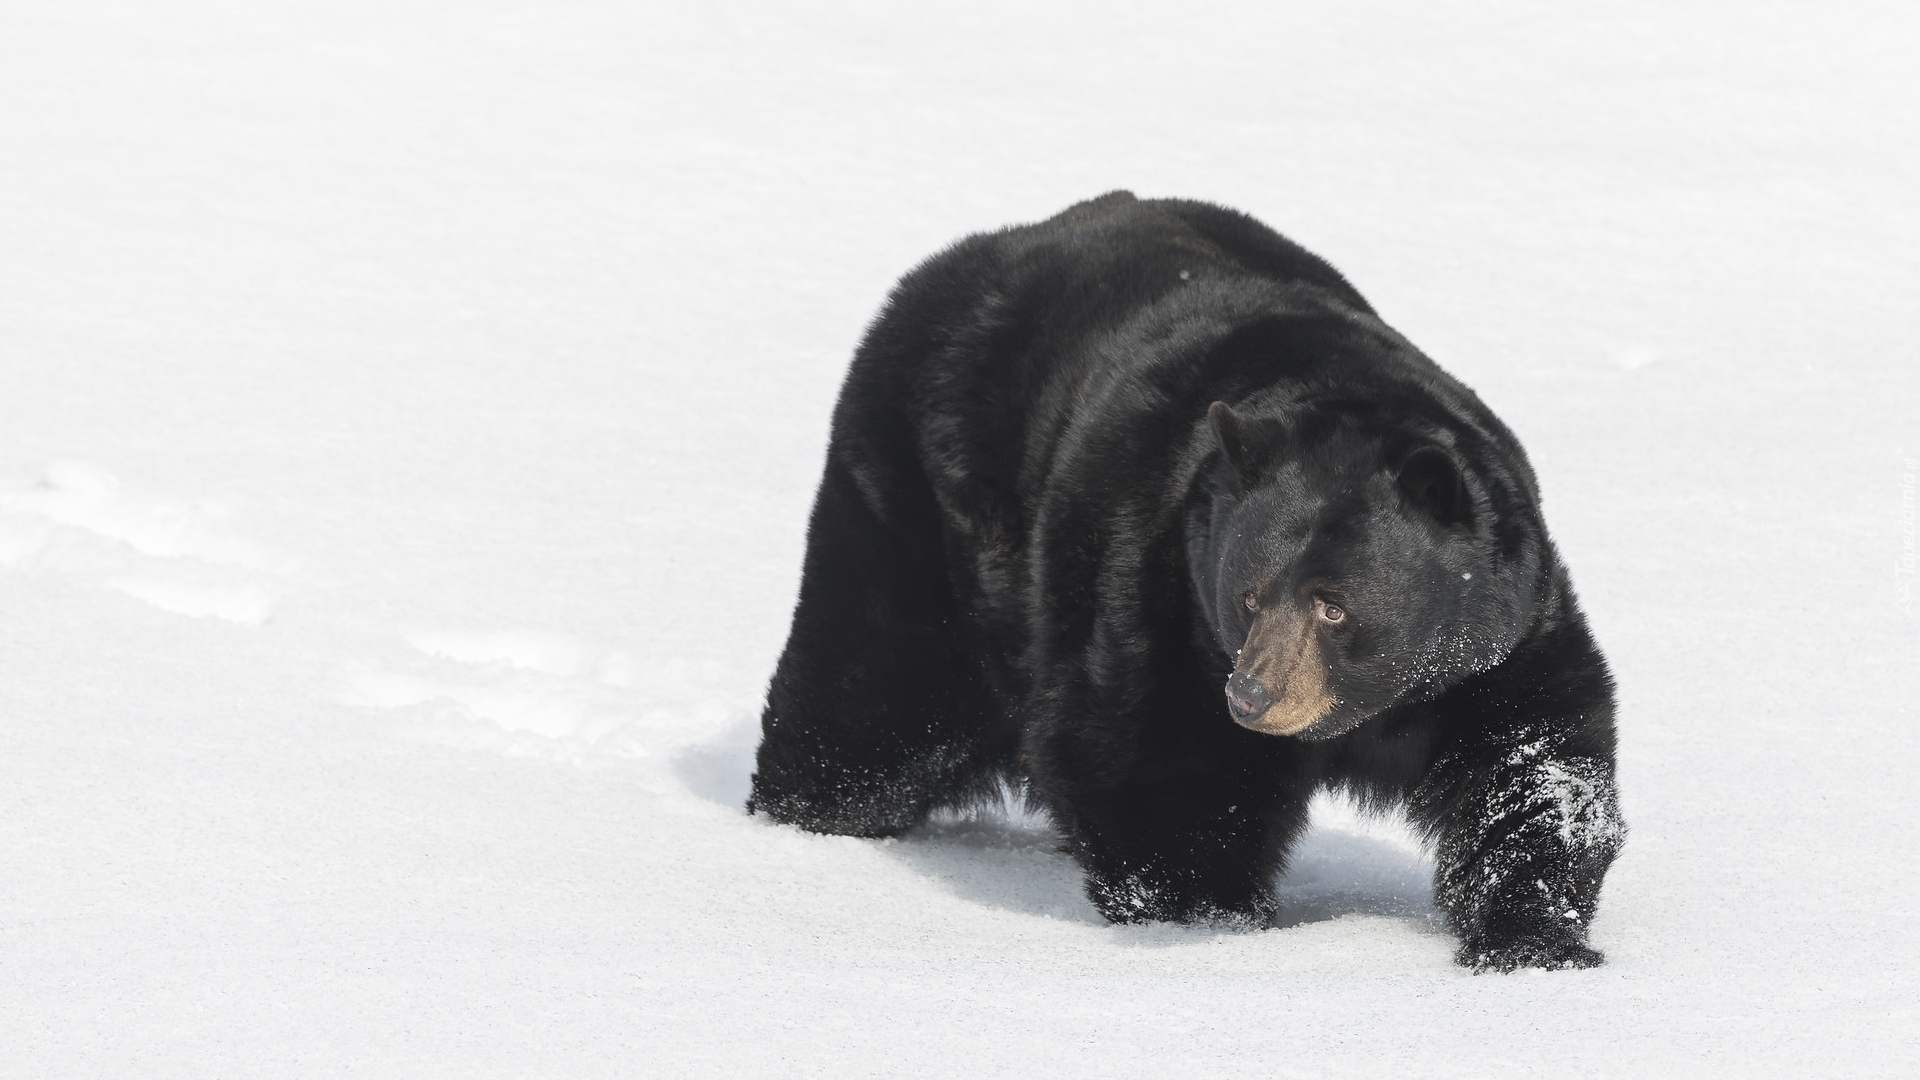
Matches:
[[1415, 734, 1626, 970]]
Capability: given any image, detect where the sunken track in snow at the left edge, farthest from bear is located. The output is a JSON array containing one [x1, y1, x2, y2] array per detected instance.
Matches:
[[0, 453, 300, 625]]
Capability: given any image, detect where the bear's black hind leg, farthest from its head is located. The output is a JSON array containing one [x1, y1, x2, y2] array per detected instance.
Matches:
[[747, 459, 1012, 836]]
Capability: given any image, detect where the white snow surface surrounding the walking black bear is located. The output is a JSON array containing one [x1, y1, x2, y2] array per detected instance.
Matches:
[[0, 0, 1920, 1078]]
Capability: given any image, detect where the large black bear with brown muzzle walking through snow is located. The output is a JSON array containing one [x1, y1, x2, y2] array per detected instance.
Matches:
[[747, 192, 1624, 970]]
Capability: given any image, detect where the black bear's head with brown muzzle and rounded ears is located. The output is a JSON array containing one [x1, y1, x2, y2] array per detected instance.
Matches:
[[1188, 402, 1540, 740]]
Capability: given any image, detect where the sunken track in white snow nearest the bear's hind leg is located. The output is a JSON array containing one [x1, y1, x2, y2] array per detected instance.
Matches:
[[342, 630, 641, 759]]
